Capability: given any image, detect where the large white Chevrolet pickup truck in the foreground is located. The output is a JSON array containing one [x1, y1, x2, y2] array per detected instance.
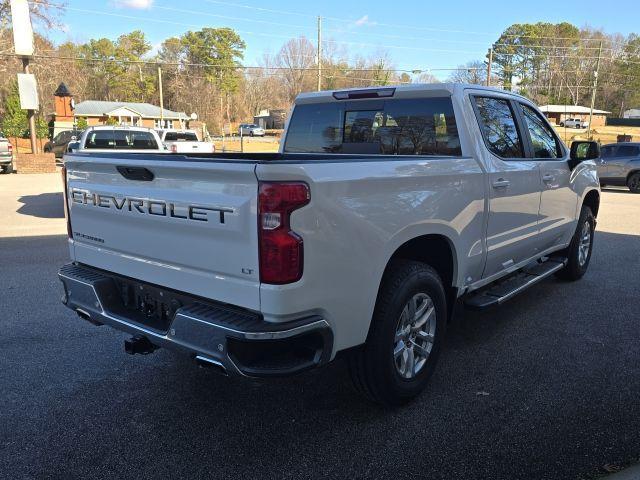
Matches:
[[59, 84, 600, 405]]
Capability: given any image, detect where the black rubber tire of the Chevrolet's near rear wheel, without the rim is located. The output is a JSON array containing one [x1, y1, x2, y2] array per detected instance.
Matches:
[[349, 260, 447, 406]]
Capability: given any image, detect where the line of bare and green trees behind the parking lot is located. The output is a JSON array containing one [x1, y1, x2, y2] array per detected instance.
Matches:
[[0, 8, 640, 134]]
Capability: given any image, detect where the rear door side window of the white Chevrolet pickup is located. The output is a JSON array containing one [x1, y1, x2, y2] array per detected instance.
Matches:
[[474, 97, 524, 158]]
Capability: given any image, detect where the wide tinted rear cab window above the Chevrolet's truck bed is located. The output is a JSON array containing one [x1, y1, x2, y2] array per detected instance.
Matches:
[[284, 97, 462, 156]]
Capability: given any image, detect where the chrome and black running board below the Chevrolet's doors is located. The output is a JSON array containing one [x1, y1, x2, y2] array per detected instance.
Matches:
[[464, 257, 567, 310]]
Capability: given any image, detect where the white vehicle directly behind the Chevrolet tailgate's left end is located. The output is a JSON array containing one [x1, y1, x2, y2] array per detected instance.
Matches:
[[67, 125, 168, 153]]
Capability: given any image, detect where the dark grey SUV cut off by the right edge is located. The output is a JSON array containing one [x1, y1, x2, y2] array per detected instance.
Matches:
[[598, 143, 640, 193]]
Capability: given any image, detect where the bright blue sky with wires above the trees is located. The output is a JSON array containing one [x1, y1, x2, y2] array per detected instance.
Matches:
[[47, 0, 640, 78]]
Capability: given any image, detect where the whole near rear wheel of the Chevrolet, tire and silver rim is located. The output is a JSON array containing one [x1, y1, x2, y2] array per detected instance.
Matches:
[[349, 260, 447, 406]]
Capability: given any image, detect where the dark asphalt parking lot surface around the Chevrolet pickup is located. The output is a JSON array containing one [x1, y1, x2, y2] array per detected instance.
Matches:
[[0, 175, 640, 479]]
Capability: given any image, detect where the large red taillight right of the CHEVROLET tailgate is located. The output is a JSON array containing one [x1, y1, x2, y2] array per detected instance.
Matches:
[[258, 182, 311, 285]]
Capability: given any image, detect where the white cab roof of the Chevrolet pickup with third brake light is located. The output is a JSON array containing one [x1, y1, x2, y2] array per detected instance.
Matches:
[[295, 83, 527, 104]]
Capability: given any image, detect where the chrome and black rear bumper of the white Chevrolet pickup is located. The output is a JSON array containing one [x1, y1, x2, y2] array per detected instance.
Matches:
[[58, 264, 333, 377]]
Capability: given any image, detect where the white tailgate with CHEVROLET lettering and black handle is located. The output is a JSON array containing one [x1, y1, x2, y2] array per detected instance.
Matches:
[[65, 155, 260, 310]]
